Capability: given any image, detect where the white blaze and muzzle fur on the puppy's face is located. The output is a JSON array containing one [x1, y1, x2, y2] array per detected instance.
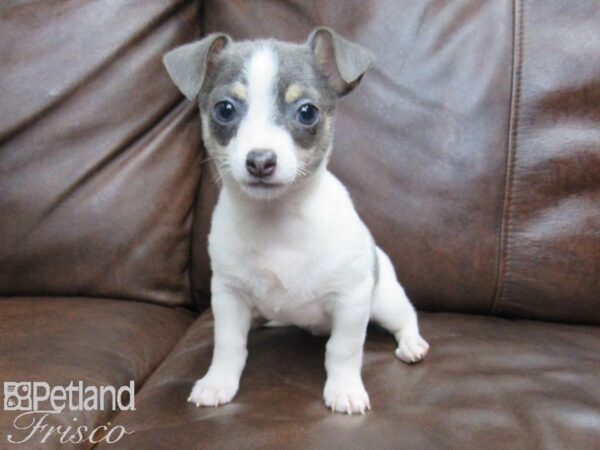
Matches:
[[229, 46, 298, 192]]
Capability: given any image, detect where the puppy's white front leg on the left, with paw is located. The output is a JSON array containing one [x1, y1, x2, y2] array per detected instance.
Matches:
[[188, 276, 252, 406]]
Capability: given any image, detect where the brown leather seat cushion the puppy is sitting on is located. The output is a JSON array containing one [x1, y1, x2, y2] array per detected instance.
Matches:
[[99, 312, 600, 449]]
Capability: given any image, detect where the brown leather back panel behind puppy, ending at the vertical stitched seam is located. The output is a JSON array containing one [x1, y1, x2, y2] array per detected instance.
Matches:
[[192, 0, 513, 313]]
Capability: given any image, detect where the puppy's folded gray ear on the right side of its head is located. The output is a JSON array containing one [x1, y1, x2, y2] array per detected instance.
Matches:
[[308, 27, 374, 97]]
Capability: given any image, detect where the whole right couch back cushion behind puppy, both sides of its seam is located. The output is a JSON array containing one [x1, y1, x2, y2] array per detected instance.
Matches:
[[192, 0, 600, 322]]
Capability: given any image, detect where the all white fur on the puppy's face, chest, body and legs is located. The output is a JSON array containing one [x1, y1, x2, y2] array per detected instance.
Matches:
[[189, 48, 428, 414]]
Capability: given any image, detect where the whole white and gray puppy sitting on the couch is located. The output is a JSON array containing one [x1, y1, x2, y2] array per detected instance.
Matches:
[[164, 28, 429, 414]]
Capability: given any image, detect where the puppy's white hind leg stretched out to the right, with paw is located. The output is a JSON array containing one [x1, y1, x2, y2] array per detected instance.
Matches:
[[371, 248, 429, 363]]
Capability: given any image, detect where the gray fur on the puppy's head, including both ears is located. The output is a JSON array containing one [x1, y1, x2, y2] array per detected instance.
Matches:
[[164, 28, 373, 176]]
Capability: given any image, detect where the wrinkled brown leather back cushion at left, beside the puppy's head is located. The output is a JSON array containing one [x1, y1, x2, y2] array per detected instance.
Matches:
[[0, 0, 200, 304]]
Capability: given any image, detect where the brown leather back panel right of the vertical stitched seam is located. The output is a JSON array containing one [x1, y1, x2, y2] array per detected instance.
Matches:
[[494, 0, 600, 324]]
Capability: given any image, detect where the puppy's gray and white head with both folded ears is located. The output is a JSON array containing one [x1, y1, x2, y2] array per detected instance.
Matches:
[[164, 28, 372, 200]]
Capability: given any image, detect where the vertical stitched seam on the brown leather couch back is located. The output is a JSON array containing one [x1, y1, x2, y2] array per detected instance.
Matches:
[[491, 0, 523, 314]]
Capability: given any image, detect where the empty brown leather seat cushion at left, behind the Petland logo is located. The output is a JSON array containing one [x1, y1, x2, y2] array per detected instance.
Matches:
[[0, 297, 194, 449]]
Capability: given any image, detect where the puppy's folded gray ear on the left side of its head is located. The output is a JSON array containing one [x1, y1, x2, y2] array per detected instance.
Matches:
[[163, 34, 231, 100]]
